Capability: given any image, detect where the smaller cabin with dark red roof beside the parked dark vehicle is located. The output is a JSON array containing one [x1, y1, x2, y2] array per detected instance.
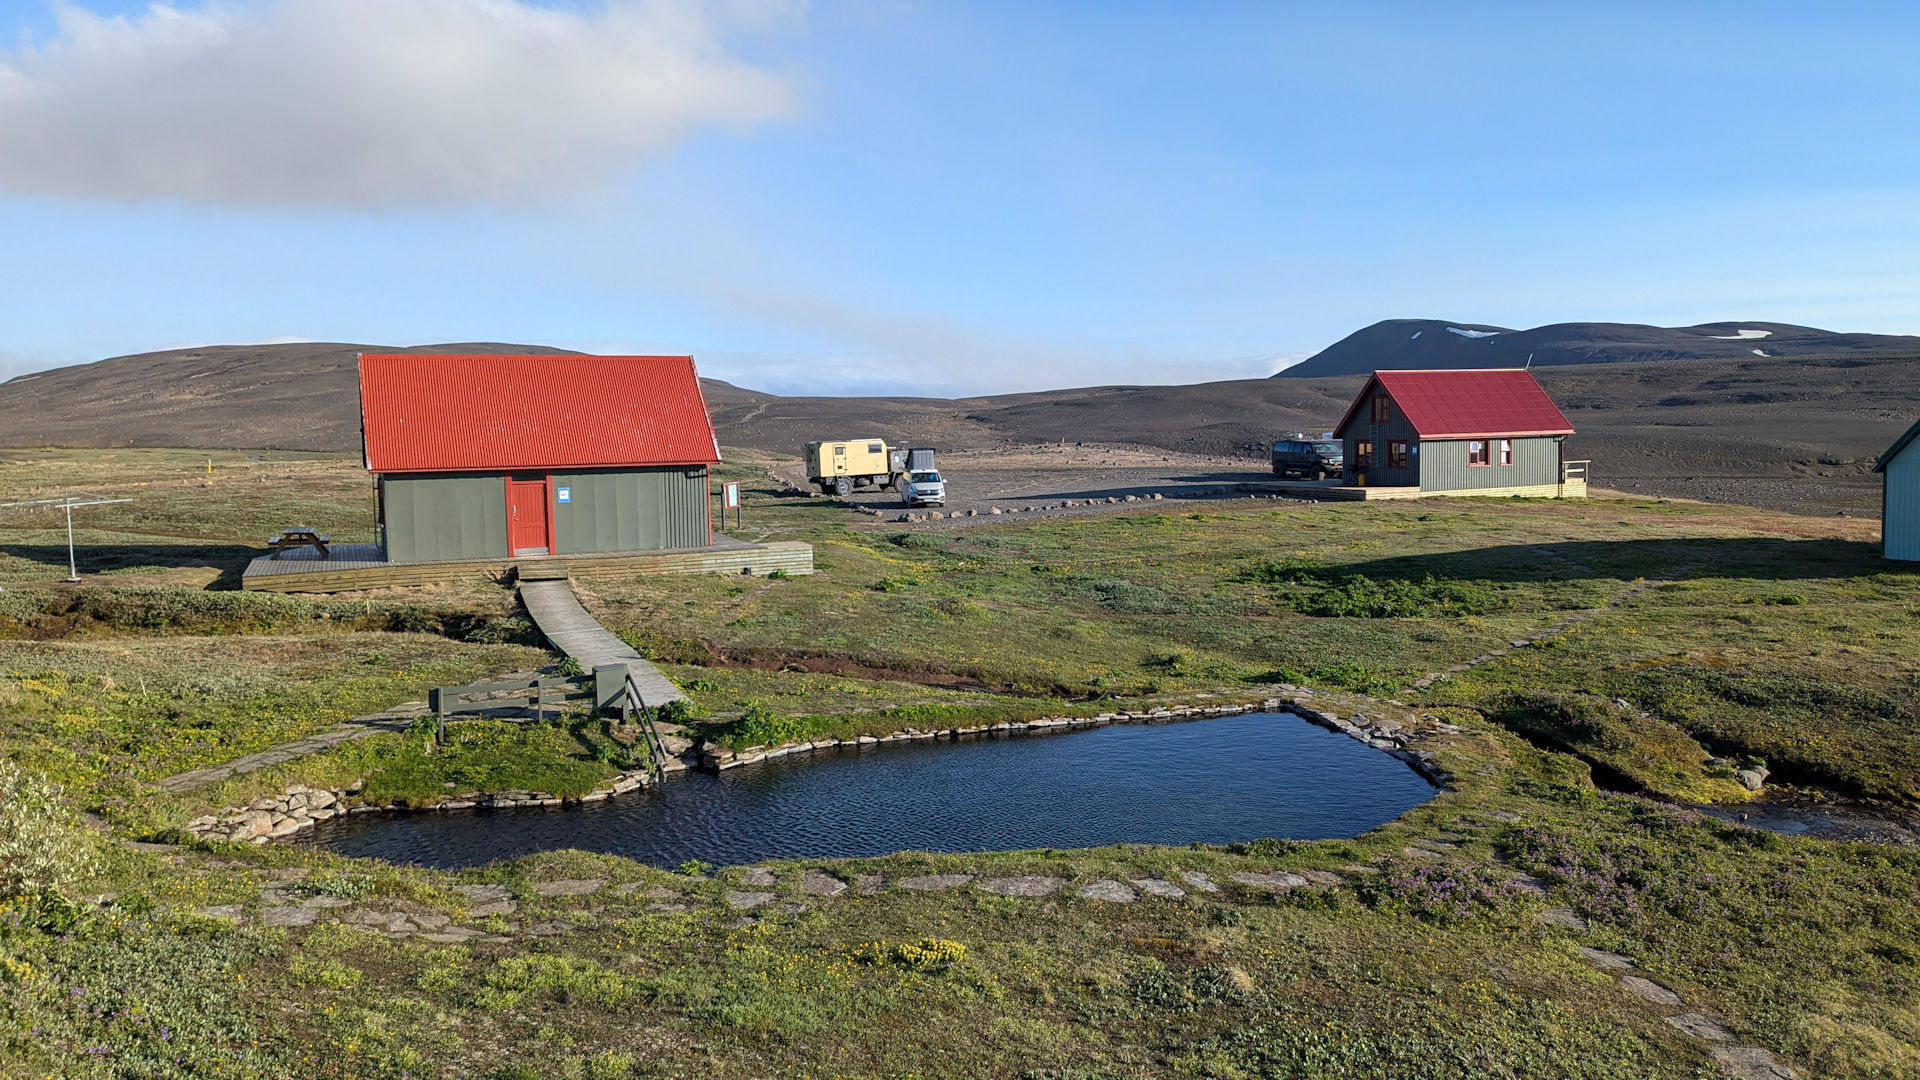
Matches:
[[1334, 367, 1586, 498]]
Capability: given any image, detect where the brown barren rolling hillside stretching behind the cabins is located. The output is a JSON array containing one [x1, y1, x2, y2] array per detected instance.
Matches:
[[0, 340, 1920, 515]]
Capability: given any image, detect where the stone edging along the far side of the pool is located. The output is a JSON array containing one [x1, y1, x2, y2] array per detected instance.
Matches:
[[186, 686, 1459, 844]]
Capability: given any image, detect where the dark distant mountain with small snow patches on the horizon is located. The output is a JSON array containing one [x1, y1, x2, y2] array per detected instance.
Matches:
[[1275, 319, 1920, 379]]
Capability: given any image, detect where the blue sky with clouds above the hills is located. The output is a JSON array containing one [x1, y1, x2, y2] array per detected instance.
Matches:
[[0, 0, 1920, 396]]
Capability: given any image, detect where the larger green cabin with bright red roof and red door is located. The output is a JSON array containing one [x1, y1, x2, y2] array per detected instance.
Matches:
[[359, 354, 720, 563]]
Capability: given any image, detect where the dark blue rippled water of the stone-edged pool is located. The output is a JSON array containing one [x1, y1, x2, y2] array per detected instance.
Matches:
[[298, 713, 1434, 867]]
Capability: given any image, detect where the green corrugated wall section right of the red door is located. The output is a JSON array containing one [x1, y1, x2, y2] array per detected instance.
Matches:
[[549, 465, 708, 555]]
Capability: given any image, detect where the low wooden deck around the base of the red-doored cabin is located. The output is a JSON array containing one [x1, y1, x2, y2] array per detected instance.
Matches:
[[240, 536, 814, 592]]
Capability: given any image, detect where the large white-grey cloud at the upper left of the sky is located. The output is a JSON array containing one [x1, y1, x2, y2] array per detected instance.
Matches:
[[0, 0, 797, 209]]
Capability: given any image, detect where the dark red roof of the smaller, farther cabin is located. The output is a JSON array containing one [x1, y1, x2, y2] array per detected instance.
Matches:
[[1334, 367, 1572, 438]]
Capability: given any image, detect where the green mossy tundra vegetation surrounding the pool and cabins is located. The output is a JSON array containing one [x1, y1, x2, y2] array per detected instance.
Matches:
[[0, 441, 1920, 1078]]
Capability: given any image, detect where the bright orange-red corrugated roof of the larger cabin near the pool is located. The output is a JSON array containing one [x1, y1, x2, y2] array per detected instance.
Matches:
[[359, 352, 720, 473]]
